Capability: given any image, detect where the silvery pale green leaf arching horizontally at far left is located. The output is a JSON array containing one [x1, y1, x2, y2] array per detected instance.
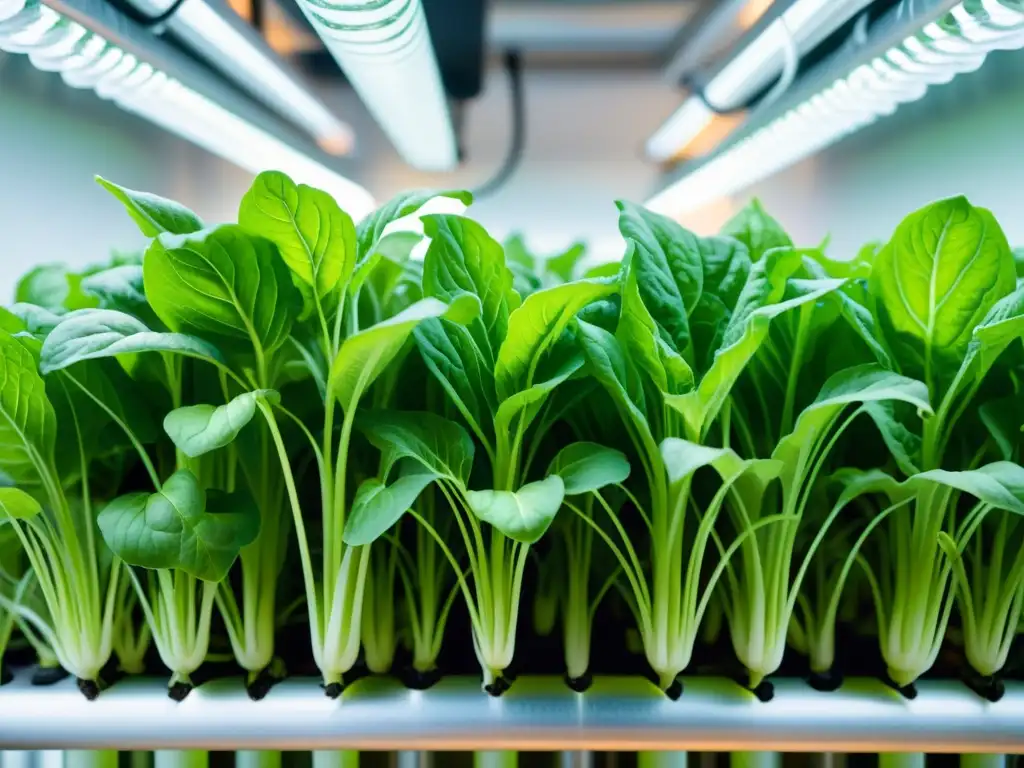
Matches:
[[39, 309, 223, 374]]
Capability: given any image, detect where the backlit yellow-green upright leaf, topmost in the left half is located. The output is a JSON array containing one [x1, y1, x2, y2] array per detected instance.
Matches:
[[239, 171, 356, 307]]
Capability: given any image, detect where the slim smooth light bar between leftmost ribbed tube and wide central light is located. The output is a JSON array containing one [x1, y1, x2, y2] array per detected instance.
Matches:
[[117, 0, 354, 155]]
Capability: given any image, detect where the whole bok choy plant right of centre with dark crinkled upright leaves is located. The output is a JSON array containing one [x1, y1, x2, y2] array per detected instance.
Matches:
[[579, 203, 836, 689]]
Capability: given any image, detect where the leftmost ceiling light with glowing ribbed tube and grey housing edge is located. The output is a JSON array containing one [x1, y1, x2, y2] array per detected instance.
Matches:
[[0, 0, 374, 219]]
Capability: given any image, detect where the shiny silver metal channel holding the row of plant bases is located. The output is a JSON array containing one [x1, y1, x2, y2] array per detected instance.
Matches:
[[0, 677, 1024, 754]]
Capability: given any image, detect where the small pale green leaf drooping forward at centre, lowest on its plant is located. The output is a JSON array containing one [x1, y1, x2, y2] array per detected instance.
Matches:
[[466, 475, 565, 544]]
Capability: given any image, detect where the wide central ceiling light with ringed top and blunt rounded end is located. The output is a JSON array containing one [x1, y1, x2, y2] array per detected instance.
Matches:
[[295, 0, 458, 171]]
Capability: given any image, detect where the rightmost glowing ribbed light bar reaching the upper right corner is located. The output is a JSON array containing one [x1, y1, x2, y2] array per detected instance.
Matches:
[[647, 0, 1024, 215]]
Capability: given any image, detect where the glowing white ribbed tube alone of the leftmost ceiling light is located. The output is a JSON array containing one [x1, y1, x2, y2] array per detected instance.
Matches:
[[0, 0, 374, 219]]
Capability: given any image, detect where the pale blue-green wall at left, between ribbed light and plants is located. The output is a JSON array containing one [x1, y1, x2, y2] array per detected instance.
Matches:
[[0, 54, 256, 294]]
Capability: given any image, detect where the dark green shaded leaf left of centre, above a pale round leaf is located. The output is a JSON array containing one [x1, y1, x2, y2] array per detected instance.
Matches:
[[355, 411, 474, 484]]
